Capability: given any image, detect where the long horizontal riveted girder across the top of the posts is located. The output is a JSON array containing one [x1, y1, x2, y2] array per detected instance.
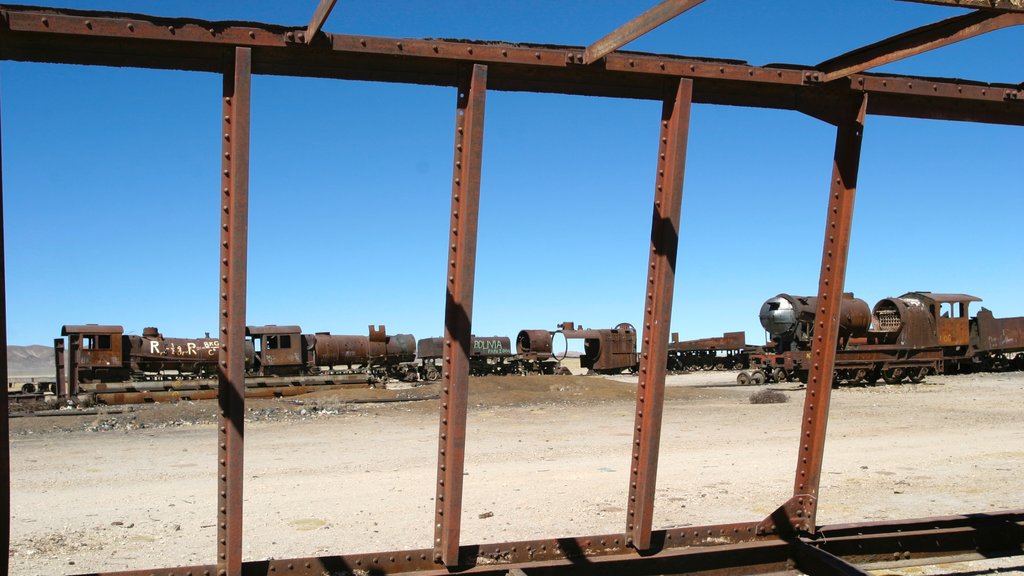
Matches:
[[0, 7, 1024, 125]]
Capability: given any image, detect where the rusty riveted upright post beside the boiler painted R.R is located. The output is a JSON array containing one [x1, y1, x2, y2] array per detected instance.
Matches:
[[217, 48, 252, 576]]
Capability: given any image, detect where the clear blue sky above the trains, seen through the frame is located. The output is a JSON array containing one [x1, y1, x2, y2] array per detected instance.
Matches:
[[0, 0, 1024, 344]]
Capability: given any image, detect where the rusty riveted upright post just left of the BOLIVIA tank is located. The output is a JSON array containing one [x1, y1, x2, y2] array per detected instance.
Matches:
[[434, 65, 487, 566]]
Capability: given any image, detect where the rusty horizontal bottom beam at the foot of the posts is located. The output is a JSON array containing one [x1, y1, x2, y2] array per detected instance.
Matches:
[[61, 510, 1024, 576]]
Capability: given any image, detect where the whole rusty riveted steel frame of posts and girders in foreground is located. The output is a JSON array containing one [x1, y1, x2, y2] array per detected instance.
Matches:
[[0, 1, 1024, 576]]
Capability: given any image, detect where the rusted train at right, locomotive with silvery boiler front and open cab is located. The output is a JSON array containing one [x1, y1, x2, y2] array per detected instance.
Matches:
[[736, 292, 1024, 384]]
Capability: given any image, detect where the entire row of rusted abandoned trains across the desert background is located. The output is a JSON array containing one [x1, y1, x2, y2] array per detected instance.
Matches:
[[16, 292, 1024, 395]]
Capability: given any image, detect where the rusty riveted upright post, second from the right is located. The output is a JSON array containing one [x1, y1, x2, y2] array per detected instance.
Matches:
[[626, 79, 693, 550]]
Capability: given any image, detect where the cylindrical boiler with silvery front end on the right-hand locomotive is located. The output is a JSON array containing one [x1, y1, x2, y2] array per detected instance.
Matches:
[[758, 292, 871, 352]]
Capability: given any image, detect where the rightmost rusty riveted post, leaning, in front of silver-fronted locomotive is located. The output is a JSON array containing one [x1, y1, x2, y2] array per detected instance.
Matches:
[[794, 94, 867, 533]]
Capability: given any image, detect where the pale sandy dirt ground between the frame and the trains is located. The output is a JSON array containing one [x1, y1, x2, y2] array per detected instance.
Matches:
[[8, 372, 1024, 575]]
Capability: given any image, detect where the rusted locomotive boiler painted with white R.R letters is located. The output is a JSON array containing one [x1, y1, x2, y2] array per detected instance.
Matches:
[[125, 327, 220, 376]]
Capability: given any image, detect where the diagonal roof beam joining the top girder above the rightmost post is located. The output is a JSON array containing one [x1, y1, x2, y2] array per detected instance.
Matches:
[[817, 10, 1024, 82]]
